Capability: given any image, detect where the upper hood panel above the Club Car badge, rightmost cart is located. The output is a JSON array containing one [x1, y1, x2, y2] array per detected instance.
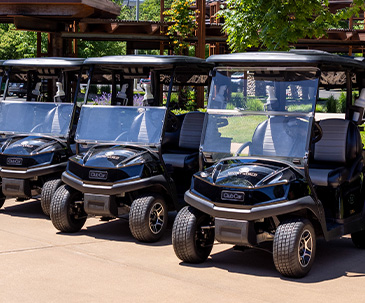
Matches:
[[196, 158, 297, 188]]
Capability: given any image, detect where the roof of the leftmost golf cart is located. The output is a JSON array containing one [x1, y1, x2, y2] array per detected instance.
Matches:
[[3, 57, 84, 71]]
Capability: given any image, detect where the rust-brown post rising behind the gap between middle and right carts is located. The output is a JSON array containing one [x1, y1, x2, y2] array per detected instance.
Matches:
[[195, 0, 206, 108]]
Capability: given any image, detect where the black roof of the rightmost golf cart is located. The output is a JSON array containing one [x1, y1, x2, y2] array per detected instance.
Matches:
[[207, 50, 365, 70]]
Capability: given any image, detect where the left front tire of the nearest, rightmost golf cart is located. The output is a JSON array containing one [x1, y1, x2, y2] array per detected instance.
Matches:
[[172, 206, 214, 263]]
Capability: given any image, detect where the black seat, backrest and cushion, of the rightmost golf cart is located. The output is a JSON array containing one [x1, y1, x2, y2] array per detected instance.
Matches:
[[309, 119, 363, 188]]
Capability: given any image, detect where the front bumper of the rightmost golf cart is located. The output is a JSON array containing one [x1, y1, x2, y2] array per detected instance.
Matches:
[[184, 190, 318, 221]]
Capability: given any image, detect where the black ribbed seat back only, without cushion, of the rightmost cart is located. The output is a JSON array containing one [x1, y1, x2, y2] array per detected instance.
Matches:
[[313, 119, 362, 166]]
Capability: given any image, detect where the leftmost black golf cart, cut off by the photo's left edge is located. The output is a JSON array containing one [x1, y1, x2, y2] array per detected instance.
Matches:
[[0, 58, 83, 215]]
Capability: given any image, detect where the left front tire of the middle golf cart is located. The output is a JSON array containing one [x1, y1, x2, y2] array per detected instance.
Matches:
[[50, 185, 87, 233]]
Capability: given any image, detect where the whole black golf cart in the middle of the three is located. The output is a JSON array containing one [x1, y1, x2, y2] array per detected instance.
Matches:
[[51, 55, 213, 242]]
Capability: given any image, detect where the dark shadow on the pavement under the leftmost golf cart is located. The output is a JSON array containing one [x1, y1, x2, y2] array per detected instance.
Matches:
[[0, 199, 49, 219]]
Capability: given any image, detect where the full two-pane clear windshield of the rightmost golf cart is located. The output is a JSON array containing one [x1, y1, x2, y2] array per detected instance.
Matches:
[[202, 68, 319, 165]]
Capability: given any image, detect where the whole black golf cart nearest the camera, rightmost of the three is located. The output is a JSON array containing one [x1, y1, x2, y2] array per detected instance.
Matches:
[[172, 50, 365, 277]]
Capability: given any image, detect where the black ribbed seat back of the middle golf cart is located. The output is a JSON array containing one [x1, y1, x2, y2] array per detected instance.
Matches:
[[179, 112, 205, 150]]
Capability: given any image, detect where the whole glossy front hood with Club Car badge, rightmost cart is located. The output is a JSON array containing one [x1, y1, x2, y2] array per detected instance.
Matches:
[[191, 158, 308, 206]]
